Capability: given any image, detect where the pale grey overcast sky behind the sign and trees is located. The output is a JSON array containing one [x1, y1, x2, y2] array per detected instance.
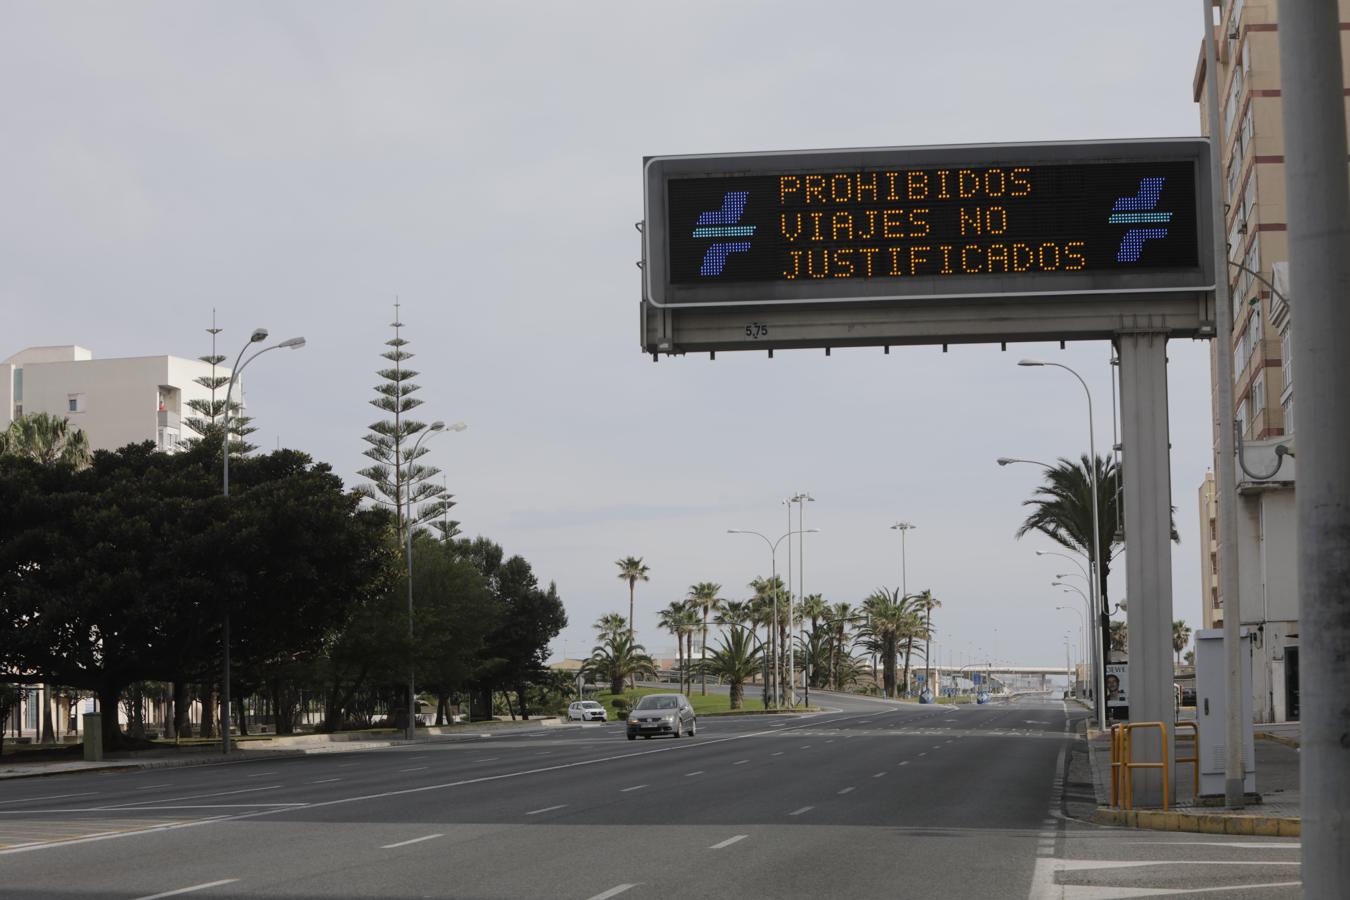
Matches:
[[0, 0, 1211, 664]]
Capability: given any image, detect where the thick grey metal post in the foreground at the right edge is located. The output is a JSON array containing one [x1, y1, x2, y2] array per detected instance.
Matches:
[[1274, 0, 1350, 897]]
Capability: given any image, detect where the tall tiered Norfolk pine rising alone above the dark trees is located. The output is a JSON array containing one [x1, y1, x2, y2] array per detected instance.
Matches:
[[358, 301, 450, 544]]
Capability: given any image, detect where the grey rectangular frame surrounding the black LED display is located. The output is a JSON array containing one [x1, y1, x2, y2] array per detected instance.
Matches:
[[643, 138, 1215, 309]]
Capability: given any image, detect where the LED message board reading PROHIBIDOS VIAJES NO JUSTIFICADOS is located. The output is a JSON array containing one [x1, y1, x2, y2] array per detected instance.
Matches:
[[644, 139, 1212, 306]]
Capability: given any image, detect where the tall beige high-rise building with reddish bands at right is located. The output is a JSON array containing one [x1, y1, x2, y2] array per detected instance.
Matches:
[[1192, 0, 1317, 722]]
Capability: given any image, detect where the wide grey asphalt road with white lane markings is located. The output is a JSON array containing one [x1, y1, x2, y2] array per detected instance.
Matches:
[[0, 696, 1299, 900]]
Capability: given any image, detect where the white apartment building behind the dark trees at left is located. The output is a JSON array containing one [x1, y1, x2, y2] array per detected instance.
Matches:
[[0, 344, 230, 452]]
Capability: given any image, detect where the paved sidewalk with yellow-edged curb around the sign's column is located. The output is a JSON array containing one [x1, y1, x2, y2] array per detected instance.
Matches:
[[1088, 722, 1303, 837]]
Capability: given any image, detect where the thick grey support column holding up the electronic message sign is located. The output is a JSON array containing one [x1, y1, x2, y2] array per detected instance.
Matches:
[[1116, 332, 1176, 806]]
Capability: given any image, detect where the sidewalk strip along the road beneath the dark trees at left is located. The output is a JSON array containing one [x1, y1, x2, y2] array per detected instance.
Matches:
[[0, 718, 569, 780]]
